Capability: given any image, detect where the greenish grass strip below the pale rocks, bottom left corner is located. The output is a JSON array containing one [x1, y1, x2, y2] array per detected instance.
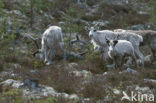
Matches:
[[0, 85, 77, 103]]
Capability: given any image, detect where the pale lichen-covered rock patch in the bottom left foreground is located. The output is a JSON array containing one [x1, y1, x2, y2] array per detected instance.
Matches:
[[0, 79, 79, 100]]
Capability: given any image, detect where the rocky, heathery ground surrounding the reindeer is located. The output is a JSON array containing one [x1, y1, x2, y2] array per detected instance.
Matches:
[[0, 0, 156, 103]]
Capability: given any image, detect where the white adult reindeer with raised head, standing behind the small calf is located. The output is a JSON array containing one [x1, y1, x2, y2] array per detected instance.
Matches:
[[86, 25, 144, 66]]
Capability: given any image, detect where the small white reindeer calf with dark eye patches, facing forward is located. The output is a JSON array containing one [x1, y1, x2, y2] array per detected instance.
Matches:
[[106, 38, 138, 68]]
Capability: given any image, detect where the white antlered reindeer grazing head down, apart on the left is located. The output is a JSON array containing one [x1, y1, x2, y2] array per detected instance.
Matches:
[[25, 26, 66, 65]]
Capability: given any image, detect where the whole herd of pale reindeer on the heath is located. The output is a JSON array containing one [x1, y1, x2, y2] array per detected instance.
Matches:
[[25, 25, 156, 68]]
